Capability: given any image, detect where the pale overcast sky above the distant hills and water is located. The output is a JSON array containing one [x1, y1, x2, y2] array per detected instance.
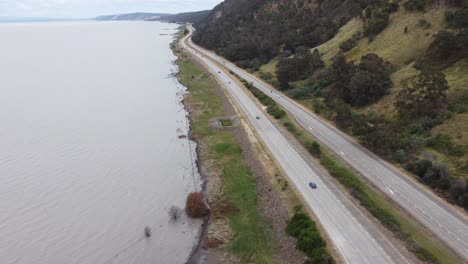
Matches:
[[0, 0, 222, 18]]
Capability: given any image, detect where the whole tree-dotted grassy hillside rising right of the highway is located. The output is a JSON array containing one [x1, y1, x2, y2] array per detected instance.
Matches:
[[194, 0, 468, 209]]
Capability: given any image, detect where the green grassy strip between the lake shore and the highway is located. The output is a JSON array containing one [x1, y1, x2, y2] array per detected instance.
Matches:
[[177, 49, 274, 263]]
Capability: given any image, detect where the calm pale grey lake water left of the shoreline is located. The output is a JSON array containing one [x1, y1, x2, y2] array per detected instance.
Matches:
[[0, 22, 201, 264]]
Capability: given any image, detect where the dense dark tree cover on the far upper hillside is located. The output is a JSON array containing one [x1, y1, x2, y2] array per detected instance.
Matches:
[[193, 0, 384, 69]]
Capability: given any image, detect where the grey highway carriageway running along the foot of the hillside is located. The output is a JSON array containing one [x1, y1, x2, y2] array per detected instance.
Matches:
[[184, 27, 468, 261]]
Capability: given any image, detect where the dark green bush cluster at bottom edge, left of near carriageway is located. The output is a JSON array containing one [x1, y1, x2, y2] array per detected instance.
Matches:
[[286, 211, 335, 264]]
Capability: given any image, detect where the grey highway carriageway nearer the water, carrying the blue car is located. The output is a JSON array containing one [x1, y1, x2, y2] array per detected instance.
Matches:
[[180, 25, 410, 264]]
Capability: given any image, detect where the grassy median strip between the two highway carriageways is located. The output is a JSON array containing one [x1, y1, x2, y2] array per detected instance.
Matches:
[[231, 73, 460, 264]]
